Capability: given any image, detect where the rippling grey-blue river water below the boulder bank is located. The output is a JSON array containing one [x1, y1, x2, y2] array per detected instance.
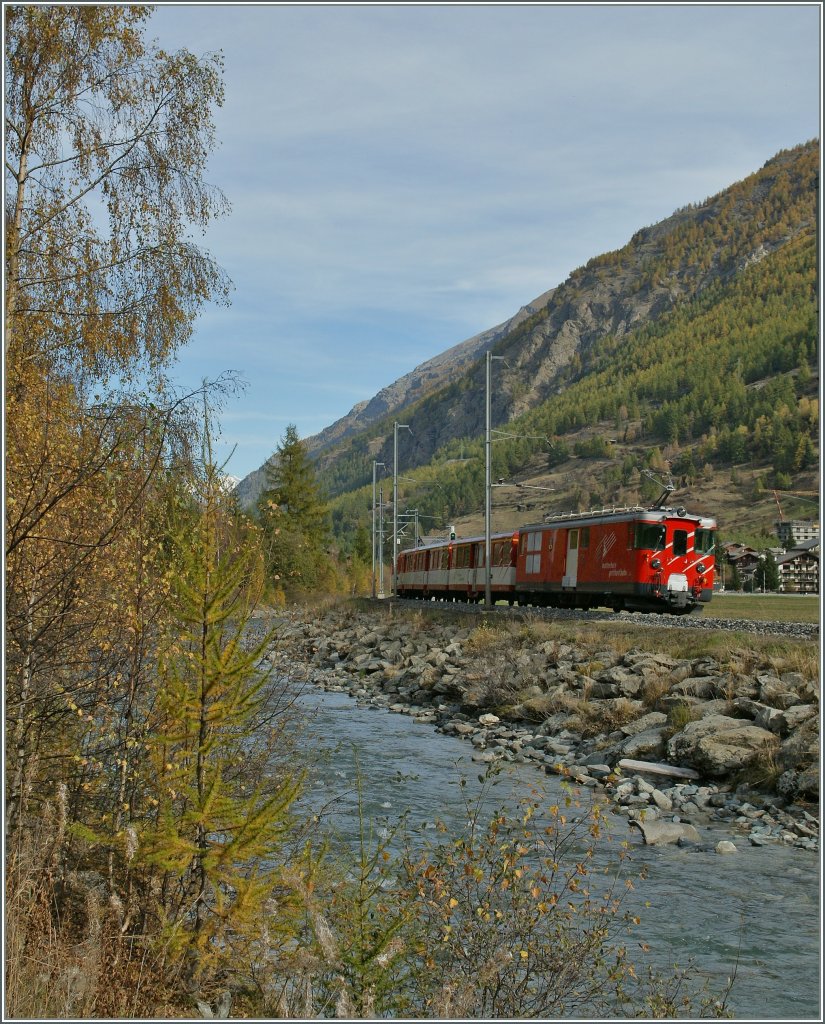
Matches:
[[290, 689, 822, 1020]]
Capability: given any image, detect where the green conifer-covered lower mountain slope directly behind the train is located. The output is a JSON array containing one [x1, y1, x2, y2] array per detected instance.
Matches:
[[333, 221, 819, 546]]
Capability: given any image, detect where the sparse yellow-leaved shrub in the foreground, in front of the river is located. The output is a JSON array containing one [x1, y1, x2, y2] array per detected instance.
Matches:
[[281, 776, 726, 1019]]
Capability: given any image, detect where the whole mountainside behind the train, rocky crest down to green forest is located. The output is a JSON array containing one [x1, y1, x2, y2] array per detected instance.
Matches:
[[319, 143, 819, 545]]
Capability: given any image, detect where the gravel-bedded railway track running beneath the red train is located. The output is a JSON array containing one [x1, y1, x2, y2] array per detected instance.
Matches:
[[380, 597, 819, 640]]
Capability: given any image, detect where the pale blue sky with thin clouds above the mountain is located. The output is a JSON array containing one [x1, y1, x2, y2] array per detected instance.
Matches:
[[146, 3, 822, 477]]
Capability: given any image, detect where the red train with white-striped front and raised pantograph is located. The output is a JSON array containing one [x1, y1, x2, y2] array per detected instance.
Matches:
[[396, 507, 717, 614]]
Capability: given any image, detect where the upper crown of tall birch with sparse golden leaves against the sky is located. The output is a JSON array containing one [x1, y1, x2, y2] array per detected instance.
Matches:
[[4, 4, 227, 377]]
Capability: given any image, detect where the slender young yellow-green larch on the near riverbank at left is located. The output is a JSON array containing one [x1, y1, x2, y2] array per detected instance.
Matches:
[[140, 421, 299, 984]]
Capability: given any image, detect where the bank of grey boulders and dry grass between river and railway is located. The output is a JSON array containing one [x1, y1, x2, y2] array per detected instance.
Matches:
[[270, 606, 819, 853]]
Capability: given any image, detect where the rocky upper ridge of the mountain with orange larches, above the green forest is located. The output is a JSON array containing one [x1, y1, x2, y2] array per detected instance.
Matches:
[[238, 140, 819, 512]]
